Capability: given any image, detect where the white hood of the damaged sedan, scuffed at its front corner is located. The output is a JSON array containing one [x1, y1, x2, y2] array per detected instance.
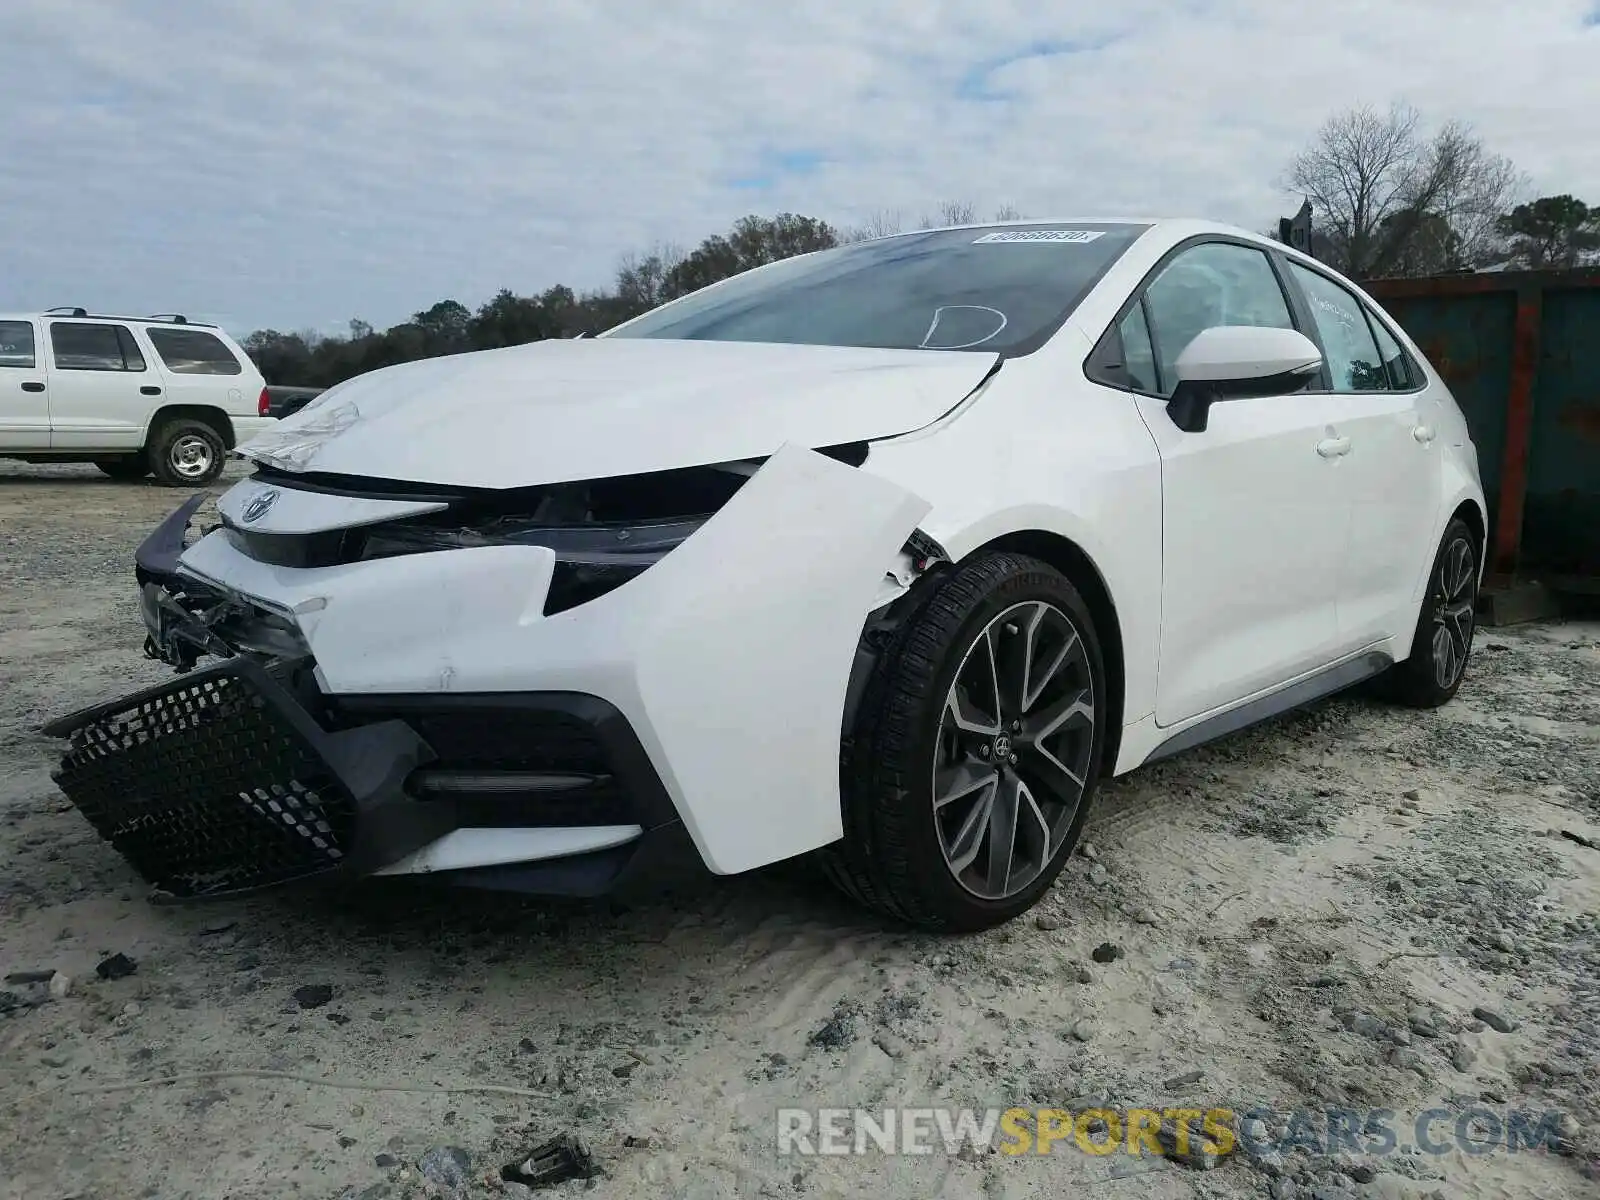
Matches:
[[238, 338, 997, 488]]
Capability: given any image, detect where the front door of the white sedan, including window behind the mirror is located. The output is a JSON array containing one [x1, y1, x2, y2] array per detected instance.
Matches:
[[1120, 240, 1350, 726]]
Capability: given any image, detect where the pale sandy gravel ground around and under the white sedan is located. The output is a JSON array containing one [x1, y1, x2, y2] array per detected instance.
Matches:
[[0, 462, 1600, 1200]]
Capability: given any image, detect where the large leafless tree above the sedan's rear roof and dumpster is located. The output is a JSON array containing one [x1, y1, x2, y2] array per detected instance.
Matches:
[[1285, 104, 1525, 278]]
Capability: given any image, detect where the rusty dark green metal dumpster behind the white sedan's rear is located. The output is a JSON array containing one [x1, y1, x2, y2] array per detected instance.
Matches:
[[1366, 269, 1600, 578]]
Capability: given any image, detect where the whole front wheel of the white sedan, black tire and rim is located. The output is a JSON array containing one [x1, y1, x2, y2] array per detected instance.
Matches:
[[822, 552, 1106, 931]]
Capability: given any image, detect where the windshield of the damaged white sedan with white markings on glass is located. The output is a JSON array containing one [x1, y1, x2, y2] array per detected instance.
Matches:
[[606, 222, 1149, 357]]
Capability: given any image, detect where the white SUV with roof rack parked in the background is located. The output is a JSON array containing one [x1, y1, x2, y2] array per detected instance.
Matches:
[[0, 309, 275, 486]]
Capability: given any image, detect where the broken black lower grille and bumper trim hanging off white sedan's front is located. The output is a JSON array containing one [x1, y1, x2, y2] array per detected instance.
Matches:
[[45, 658, 698, 899]]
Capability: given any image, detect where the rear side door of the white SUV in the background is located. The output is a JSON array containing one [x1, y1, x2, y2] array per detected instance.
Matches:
[[50, 320, 162, 450]]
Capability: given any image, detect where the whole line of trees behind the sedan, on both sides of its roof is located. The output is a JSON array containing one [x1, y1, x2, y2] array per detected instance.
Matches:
[[245, 106, 1600, 387]]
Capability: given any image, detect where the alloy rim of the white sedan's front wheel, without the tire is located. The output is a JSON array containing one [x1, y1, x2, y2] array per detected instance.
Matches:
[[933, 600, 1094, 901]]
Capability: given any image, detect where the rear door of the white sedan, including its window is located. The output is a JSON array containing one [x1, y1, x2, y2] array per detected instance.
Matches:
[[1288, 262, 1443, 650]]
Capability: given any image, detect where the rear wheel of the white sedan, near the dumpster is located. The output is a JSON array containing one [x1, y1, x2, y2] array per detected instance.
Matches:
[[1379, 517, 1478, 709]]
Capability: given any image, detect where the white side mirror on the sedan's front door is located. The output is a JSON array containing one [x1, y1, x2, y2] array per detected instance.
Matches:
[[1166, 325, 1322, 434]]
